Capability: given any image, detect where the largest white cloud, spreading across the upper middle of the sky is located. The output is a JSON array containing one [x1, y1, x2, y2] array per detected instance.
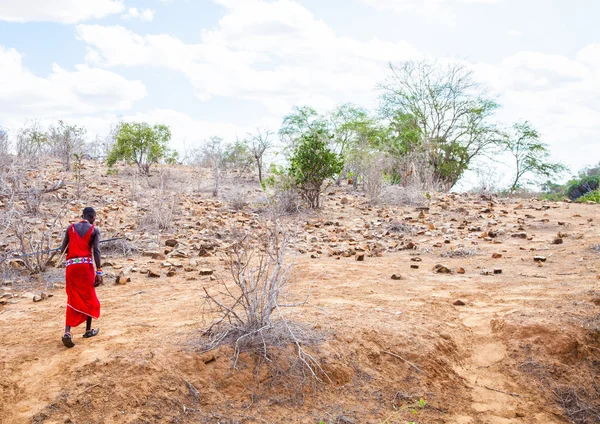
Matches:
[[78, 0, 419, 114]]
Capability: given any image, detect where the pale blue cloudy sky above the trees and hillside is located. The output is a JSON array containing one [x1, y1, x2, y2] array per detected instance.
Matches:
[[0, 0, 600, 179]]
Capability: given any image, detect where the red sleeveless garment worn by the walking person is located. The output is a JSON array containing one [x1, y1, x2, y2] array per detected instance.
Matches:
[[65, 224, 100, 327]]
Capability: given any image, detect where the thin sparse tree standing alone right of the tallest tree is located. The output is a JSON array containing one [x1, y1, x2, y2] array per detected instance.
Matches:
[[503, 121, 567, 193]]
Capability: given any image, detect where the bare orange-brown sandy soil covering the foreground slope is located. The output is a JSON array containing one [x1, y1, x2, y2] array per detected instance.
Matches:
[[0, 164, 600, 424]]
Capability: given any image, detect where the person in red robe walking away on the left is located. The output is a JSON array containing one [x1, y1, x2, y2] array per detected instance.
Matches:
[[61, 207, 102, 347]]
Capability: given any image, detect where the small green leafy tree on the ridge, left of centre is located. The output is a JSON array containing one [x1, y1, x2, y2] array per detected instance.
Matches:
[[106, 122, 177, 175]]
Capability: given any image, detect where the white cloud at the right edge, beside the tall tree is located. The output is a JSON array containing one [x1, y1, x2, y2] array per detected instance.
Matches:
[[474, 44, 600, 175]]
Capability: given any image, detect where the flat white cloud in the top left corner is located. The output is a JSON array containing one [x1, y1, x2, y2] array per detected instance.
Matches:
[[0, 0, 124, 24]]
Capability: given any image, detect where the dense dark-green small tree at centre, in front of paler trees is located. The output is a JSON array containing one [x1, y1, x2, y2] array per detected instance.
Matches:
[[289, 130, 344, 209]]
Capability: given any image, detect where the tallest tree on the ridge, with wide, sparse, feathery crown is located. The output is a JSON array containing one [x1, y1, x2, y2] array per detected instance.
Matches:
[[379, 60, 500, 189]]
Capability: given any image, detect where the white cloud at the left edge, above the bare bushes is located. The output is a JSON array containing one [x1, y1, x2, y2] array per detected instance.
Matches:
[[0, 46, 146, 119]]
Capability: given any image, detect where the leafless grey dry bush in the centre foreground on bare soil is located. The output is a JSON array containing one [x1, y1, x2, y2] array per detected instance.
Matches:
[[204, 222, 327, 381]]
